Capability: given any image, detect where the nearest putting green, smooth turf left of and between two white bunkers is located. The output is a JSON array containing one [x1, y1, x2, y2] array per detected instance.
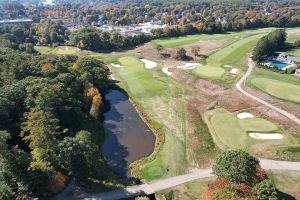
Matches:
[[210, 110, 278, 149]]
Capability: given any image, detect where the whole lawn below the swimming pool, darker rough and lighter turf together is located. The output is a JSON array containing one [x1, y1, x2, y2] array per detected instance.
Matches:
[[246, 67, 300, 104]]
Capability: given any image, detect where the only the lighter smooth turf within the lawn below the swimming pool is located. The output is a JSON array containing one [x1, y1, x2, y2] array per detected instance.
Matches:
[[251, 75, 300, 103]]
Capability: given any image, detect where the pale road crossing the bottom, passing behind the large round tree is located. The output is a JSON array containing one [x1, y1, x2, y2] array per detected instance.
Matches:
[[83, 159, 300, 200]]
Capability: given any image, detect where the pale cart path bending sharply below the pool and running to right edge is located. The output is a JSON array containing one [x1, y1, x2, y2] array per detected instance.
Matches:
[[235, 58, 300, 125]]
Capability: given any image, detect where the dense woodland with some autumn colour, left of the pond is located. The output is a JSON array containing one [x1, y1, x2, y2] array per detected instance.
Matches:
[[0, 48, 112, 199]]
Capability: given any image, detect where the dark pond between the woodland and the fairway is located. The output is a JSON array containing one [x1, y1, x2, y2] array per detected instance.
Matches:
[[102, 90, 155, 177]]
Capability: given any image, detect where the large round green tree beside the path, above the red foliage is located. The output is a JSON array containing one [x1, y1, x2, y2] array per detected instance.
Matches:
[[213, 150, 259, 184]]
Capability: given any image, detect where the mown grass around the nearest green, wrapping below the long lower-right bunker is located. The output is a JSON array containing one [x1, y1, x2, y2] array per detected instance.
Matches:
[[209, 109, 289, 153]]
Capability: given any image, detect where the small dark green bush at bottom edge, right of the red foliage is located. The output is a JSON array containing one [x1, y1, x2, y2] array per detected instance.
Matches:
[[252, 180, 278, 200]]
